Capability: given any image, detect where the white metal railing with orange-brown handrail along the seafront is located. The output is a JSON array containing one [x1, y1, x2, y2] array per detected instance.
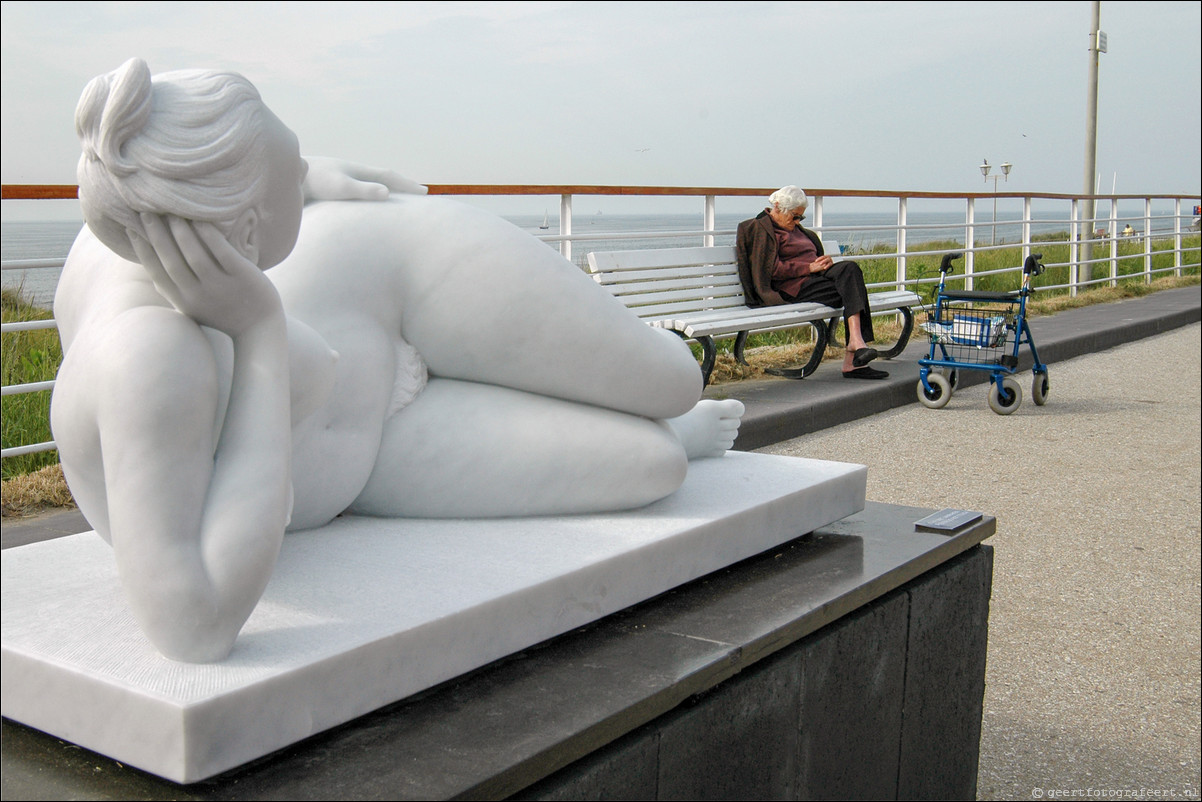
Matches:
[[0, 185, 1200, 457]]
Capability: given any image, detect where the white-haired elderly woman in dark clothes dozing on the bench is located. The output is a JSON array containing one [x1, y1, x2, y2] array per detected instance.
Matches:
[[737, 185, 889, 379]]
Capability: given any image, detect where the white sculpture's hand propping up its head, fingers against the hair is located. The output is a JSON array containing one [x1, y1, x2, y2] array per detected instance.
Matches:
[[129, 214, 284, 337]]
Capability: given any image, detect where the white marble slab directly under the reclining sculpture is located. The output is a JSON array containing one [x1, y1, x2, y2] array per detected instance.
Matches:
[[0, 452, 867, 783]]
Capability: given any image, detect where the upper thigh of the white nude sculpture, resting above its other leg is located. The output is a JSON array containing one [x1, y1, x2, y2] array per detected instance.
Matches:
[[403, 242, 702, 418]]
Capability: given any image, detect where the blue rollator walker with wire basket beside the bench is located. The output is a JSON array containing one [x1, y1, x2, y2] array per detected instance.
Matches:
[[917, 254, 1048, 415]]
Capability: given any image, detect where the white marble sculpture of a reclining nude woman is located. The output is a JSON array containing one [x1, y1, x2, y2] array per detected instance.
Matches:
[[52, 59, 743, 663]]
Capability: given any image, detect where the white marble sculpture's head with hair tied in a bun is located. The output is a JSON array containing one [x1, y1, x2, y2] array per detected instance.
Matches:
[[76, 59, 308, 269]]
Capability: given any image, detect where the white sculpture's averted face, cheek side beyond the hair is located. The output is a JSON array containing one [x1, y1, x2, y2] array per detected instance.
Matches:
[[257, 111, 309, 271]]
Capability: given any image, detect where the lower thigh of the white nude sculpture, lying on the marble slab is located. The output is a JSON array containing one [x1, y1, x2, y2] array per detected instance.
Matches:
[[351, 379, 688, 517]]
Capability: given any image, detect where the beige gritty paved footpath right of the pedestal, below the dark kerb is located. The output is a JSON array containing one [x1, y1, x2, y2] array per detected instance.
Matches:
[[761, 323, 1202, 800]]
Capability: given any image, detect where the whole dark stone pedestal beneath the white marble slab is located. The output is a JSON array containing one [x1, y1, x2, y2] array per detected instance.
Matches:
[[2, 504, 995, 800]]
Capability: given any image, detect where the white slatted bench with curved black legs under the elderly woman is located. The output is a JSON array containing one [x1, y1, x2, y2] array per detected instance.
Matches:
[[588, 242, 922, 384]]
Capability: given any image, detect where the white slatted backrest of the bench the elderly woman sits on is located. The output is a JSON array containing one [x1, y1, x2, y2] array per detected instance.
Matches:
[[588, 239, 839, 320]]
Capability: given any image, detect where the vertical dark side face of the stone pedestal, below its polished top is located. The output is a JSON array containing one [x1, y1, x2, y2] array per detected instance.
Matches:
[[517, 538, 993, 800]]
